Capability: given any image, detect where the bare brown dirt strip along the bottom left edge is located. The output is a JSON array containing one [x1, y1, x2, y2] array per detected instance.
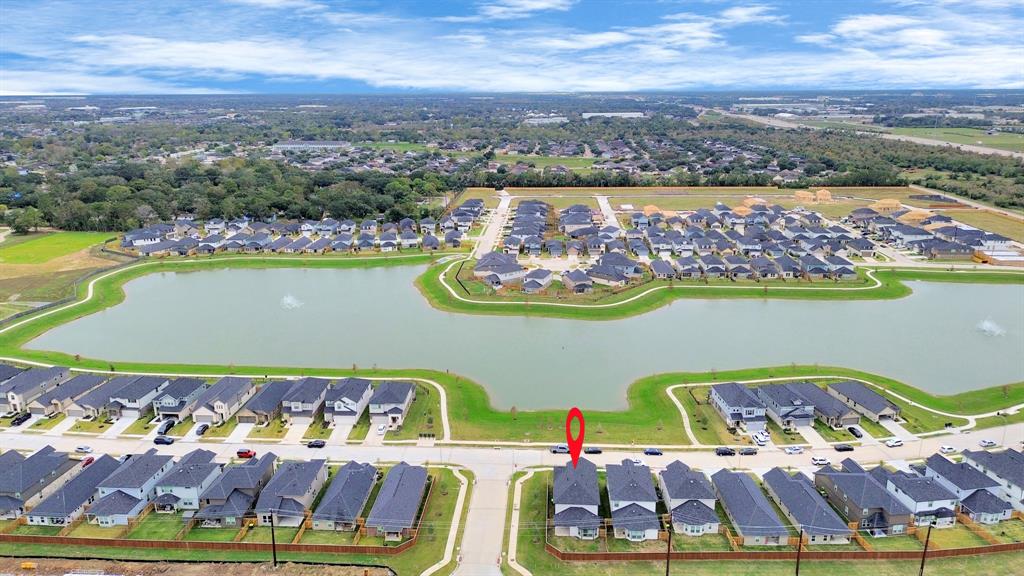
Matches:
[[0, 558, 390, 576]]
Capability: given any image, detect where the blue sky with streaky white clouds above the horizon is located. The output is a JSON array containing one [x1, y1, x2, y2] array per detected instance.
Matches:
[[0, 0, 1024, 95]]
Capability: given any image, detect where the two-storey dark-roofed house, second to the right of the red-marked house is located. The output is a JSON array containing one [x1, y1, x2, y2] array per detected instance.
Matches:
[[658, 460, 720, 536]]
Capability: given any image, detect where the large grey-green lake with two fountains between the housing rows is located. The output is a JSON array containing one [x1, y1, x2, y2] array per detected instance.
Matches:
[[28, 265, 1024, 409]]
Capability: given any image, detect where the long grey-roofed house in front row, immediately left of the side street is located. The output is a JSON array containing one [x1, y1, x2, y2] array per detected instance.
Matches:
[[366, 462, 427, 541]]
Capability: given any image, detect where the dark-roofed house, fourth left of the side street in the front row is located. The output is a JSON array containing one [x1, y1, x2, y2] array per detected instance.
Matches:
[[195, 452, 278, 528]]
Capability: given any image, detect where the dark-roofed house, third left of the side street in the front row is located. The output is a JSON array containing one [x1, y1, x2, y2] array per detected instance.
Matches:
[[255, 460, 328, 526]]
